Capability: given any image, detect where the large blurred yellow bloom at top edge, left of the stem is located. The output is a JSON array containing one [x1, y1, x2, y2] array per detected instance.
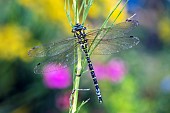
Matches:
[[18, 0, 71, 29]]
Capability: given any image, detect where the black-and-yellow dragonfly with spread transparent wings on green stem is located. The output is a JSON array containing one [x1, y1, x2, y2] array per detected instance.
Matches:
[[28, 19, 139, 103]]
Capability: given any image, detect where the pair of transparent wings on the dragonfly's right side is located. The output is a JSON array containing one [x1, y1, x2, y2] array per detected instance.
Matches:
[[86, 20, 139, 54]]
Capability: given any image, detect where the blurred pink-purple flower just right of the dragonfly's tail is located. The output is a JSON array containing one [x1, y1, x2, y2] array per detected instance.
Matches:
[[94, 59, 127, 82]]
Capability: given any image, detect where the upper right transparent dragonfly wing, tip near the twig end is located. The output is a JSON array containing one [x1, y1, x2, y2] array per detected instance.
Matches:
[[87, 20, 139, 38]]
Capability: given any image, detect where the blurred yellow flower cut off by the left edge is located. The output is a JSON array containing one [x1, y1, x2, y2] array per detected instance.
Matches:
[[0, 24, 30, 61]]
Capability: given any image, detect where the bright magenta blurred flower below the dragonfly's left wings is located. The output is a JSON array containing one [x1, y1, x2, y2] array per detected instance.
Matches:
[[43, 64, 71, 89]]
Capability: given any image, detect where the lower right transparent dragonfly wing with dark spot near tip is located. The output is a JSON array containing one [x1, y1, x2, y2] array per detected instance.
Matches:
[[88, 36, 139, 55]]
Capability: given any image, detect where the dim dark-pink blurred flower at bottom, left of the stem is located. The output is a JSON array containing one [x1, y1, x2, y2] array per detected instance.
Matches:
[[56, 93, 70, 110]]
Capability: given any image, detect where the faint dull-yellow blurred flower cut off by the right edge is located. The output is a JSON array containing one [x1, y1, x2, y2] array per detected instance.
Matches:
[[158, 17, 170, 43]]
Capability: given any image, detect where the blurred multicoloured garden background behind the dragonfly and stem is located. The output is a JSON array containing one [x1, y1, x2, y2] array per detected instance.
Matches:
[[0, 0, 170, 113]]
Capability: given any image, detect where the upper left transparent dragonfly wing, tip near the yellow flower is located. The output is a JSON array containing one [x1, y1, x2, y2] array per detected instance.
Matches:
[[28, 38, 75, 57]]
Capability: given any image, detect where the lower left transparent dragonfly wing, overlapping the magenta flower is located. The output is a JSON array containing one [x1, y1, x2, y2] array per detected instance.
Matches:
[[34, 46, 77, 74]]
